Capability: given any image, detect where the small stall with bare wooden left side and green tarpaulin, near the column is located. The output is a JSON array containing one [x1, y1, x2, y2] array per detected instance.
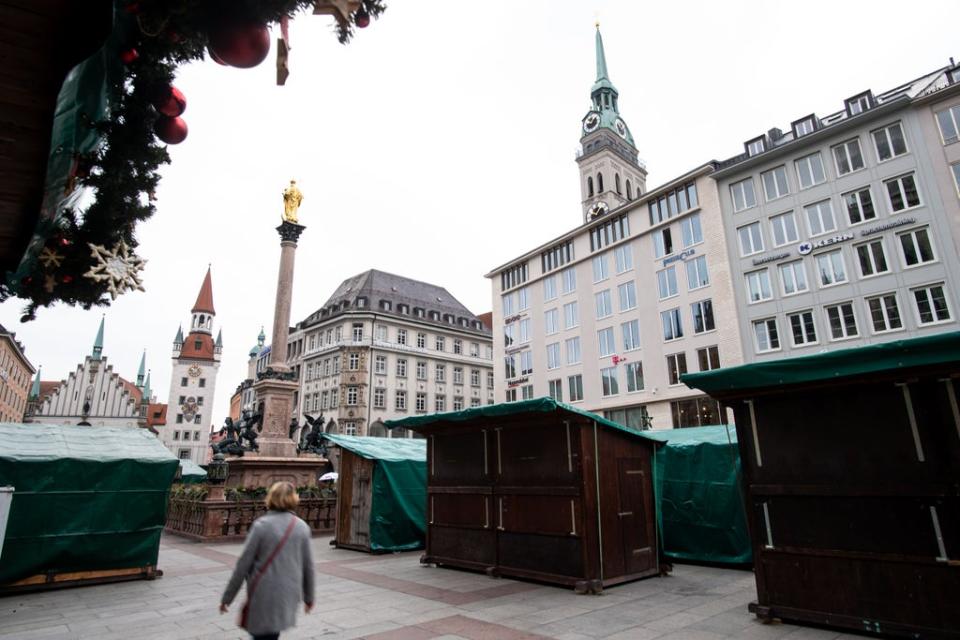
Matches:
[[323, 434, 427, 552]]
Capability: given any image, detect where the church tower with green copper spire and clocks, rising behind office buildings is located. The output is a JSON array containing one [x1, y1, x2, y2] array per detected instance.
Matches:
[[577, 24, 647, 222]]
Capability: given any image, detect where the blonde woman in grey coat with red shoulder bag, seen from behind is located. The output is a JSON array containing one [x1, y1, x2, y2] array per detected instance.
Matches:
[[220, 482, 314, 640]]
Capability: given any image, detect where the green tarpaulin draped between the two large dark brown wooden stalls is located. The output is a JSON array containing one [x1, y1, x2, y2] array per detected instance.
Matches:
[[646, 425, 752, 564]]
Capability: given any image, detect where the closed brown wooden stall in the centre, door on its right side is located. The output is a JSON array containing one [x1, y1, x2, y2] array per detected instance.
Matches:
[[386, 398, 660, 592]]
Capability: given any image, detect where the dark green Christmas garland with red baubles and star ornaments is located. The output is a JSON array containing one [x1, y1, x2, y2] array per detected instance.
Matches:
[[0, 0, 386, 321]]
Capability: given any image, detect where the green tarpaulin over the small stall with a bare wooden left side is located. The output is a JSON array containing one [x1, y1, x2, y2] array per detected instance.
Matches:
[[324, 434, 427, 551]]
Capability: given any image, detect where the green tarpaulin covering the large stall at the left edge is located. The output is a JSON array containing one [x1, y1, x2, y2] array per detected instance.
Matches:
[[0, 423, 178, 583]]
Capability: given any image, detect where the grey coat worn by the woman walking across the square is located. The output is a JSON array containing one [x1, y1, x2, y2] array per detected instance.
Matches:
[[220, 511, 314, 635]]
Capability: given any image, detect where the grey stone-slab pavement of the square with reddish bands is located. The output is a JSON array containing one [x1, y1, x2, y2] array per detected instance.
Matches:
[[0, 536, 860, 640]]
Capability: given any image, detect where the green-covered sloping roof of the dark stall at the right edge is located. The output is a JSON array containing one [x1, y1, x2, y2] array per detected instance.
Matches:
[[680, 331, 960, 396]]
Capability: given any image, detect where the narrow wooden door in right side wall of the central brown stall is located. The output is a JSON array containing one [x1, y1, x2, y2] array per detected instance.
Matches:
[[617, 458, 656, 575]]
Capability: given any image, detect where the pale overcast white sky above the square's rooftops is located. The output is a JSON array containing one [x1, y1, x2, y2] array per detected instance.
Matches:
[[0, 0, 960, 426]]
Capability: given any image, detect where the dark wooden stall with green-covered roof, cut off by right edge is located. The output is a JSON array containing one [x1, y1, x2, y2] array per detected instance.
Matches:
[[683, 333, 960, 638]]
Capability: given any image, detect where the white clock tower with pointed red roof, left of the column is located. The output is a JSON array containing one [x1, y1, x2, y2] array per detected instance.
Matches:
[[159, 268, 223, 464]]
